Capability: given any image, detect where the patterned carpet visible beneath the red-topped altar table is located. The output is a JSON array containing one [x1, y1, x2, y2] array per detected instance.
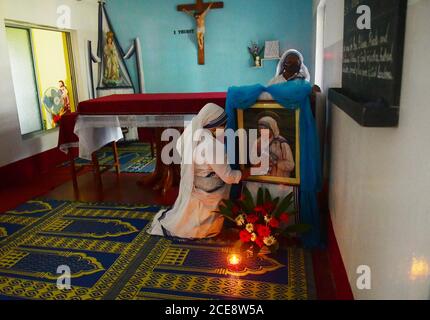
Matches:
[[61, 142, 156, 173]]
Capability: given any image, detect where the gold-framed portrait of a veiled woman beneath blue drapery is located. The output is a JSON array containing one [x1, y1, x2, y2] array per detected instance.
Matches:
[[237, 101, 300, 186]]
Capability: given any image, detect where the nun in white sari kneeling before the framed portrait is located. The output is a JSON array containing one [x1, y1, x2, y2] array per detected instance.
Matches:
[[148, 103, 242, 239]]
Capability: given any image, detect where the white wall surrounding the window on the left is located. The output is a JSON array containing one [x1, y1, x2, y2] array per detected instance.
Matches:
[[0, 0, 98, 166]]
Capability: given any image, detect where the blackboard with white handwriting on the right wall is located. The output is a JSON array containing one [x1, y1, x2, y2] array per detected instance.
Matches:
[[342, 0, 407, 107]]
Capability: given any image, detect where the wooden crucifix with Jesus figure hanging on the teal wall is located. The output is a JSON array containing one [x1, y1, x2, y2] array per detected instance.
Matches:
[[178, 0, 224, 64]]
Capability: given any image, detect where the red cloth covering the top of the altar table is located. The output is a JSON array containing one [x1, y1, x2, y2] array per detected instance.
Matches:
[[78, 92, 227, 115]]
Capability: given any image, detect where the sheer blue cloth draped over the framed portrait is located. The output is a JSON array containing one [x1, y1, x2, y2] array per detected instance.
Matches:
[[226, 79, 322, 248]]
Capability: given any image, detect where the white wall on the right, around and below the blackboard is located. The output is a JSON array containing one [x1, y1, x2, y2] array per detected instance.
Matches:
[[324, 0, 430, 299]]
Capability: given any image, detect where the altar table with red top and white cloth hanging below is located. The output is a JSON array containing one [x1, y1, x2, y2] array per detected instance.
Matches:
[[58, 92, 227, 195]]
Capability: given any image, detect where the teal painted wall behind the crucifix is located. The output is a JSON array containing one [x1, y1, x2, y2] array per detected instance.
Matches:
[[106, 0, 313, 93]]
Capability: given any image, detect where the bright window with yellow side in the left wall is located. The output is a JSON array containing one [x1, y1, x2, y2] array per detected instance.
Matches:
[[6, 25, 76, 135]]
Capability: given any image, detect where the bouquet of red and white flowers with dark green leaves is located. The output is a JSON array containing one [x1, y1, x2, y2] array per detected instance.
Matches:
[[219, 188, 310, 253]]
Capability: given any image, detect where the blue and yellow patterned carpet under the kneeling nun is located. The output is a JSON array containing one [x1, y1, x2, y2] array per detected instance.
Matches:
[[0, 200, 315, 300]]
